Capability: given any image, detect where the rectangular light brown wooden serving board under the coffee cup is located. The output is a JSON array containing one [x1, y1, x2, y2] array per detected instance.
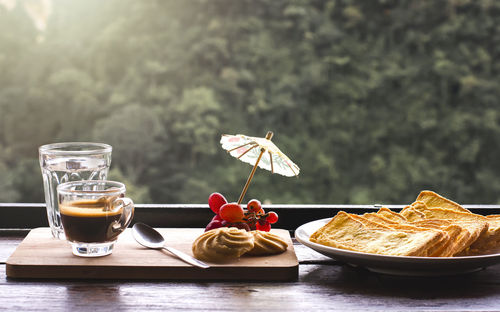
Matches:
[[6, 228, 299, 281]]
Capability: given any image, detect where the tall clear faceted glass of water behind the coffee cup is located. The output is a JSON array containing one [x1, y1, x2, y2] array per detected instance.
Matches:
[[38, 142, 112, 239]]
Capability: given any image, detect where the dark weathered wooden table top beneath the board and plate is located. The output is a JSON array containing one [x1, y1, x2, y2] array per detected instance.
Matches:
[[0, 231, 500, 311]]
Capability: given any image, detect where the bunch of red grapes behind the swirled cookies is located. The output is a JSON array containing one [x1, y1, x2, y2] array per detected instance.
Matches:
[[205, 193, 278, 232]]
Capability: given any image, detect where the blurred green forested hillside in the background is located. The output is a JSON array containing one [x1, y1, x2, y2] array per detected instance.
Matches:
[[0, 0, 500, 204]]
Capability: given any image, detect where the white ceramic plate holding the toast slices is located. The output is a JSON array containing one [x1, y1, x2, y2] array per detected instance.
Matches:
[[295, 218, 500, 276]]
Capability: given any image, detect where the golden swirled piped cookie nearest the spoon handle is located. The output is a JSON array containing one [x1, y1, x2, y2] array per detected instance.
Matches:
[[192, 227, 254, 262]]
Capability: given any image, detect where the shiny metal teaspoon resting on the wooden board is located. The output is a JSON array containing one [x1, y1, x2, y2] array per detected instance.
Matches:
[[132, 223, 210, 269]]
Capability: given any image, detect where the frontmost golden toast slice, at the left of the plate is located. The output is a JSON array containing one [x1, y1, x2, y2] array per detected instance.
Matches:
[[309, 211, 442, 256]]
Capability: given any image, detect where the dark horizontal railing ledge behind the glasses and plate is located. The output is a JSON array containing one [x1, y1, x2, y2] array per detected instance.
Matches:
[[0, 203, 500, 231]]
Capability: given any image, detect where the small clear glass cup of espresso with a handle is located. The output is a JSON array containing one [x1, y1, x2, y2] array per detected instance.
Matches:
[[57, 180, 134, 257]]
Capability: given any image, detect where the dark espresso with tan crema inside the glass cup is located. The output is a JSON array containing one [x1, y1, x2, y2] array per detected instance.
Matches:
[[59, 199, 122, 243]]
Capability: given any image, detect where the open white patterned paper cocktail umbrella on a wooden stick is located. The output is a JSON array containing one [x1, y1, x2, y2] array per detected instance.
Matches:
[[220, 131, 300, 204]]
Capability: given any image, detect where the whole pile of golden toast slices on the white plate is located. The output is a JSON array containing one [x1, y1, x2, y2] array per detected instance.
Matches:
[[310, 191, 500, 257]]
